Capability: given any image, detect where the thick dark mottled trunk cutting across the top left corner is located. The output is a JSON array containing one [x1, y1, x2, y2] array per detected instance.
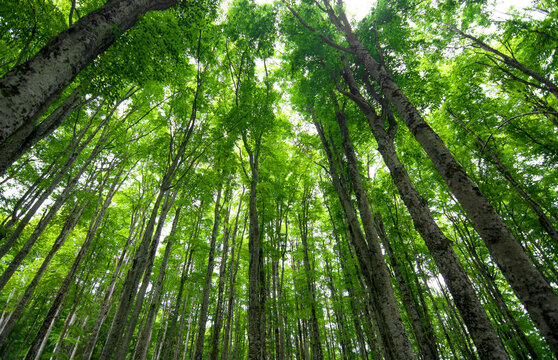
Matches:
[[0, 0, 176, 144]]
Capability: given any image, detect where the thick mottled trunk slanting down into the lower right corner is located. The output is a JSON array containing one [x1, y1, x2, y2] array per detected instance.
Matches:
[[306, 0, 558, 354]]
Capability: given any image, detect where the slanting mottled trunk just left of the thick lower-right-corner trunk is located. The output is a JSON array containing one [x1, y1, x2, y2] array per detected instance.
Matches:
[[337, 67, 509, 359]]
